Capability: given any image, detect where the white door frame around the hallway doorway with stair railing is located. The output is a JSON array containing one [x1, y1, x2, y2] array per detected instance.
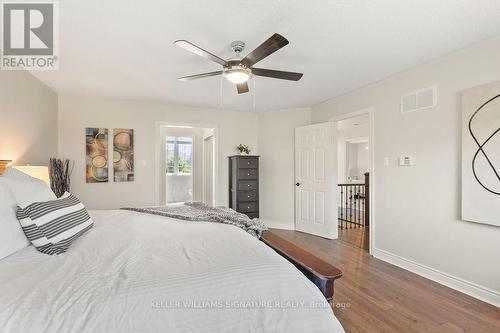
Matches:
[[328, 106, 376, 255]]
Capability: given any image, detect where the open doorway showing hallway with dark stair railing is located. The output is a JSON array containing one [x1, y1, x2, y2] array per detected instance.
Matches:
[[334, 113, 371, 251]]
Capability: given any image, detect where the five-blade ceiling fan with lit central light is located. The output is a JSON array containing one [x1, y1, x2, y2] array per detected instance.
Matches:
[[174, 34, 303, 94]]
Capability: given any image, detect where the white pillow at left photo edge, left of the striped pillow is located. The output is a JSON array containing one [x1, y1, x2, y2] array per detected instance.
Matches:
[[0, 182, 30, 259]]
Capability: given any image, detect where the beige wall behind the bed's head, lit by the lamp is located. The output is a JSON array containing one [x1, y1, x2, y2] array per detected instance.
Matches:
[[0, 70, 57, 165]]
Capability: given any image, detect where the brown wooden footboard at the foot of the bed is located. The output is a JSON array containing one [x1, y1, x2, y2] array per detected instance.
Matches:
[[261, 231, 342, 301]]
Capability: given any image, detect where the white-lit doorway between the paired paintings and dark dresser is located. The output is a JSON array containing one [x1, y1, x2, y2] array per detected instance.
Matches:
[[157, 124, 216, 206]]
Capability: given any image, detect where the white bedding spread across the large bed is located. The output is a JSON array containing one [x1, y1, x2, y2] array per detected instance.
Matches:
[[0, 211, 343, 333]]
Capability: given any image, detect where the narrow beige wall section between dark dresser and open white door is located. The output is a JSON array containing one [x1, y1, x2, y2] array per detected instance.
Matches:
[[258, 108, 311, 229]]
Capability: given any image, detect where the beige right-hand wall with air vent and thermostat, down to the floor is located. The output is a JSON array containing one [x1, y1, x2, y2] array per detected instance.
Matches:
[[312, 39, 500, 305]]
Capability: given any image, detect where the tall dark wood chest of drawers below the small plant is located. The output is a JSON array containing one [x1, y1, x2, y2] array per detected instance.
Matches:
[[229, 155, 259, 218]]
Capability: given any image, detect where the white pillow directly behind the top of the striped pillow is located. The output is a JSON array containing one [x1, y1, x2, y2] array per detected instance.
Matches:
[[0, 168, 56, 204]]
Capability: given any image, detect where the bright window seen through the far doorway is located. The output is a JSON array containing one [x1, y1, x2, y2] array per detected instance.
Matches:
[[165, 136, 193, 174]]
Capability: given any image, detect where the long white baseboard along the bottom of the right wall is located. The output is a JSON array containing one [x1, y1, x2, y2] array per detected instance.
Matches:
[[372, 248, 500, 307]]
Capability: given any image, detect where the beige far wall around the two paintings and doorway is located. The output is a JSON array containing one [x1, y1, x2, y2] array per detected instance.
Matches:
[[59, 94, 257, 209]]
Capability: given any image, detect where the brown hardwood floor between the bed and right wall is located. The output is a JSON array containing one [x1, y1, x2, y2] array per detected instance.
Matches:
[[272, 229, 500, 333]]
